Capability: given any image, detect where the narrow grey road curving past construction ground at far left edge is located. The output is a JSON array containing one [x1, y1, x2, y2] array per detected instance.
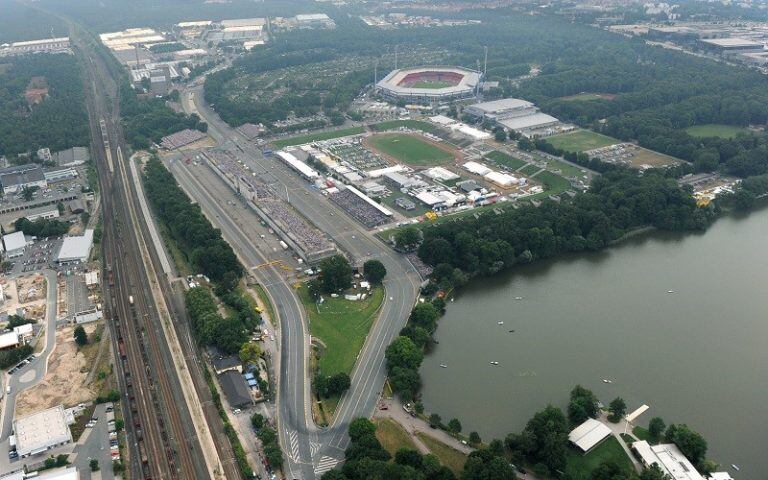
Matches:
[[0, 270, 57, 472]]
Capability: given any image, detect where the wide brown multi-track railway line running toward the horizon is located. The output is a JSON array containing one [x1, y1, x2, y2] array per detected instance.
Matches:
[[76, 25, 214, 480]]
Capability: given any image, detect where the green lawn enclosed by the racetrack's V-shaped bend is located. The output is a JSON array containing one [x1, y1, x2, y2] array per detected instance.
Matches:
[[299, 285, 384, 375]]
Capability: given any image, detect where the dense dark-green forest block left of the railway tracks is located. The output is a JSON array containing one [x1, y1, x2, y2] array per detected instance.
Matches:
[[0, 54, 90, 156]]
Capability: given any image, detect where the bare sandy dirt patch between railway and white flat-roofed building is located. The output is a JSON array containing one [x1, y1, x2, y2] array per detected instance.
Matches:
[[14, 323, 98, 417]]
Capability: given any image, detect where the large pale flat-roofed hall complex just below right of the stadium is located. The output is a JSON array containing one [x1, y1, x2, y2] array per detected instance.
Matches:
[[464, 98, 560, 135]]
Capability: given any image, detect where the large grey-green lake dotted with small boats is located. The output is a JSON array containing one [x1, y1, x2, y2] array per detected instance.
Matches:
[[421, 209, 768, 480]]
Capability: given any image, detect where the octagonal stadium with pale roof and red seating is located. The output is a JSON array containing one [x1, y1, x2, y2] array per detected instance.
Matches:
[[376, 66, 481, 103]]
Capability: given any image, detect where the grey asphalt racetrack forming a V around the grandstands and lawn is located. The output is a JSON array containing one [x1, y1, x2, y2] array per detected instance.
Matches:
[[180, 86, 421, 479]]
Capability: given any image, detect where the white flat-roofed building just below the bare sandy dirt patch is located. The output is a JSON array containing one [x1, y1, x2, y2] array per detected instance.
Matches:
[[13, 405, 72, 458]]
